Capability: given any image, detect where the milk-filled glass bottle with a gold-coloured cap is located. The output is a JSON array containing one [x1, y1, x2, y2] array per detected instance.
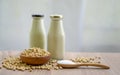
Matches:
[[47, 15, 65, 59]]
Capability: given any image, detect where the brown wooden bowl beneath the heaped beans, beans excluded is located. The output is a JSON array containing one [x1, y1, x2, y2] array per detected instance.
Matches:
[[20, 55, 51, 65]]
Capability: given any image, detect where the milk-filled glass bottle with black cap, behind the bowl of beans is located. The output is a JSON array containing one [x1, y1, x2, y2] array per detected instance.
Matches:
[[30, 15, 46, 49]]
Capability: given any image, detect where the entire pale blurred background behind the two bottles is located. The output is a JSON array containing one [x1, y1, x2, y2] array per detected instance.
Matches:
[[0, 0, 120, 52]]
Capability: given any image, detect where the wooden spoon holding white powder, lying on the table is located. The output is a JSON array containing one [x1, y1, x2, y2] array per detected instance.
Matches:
[[57, 60, 110, 69]]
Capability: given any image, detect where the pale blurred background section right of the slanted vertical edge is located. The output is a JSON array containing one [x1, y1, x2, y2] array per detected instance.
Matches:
[[82, 0, 120, 52]]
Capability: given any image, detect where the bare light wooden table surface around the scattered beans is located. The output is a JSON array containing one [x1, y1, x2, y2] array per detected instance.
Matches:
[[0, 51, 120, 75]]
